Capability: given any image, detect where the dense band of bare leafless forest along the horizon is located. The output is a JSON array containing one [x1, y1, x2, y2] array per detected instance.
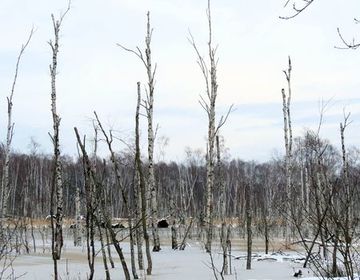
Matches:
[[1, 131, 360, 235]]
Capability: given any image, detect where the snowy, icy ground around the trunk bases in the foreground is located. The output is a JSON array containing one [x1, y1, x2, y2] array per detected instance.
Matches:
[[4, 236, 316, 280]]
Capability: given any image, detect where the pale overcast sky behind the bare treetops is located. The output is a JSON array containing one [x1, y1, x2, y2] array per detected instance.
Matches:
[[0, 0, 360, 161]]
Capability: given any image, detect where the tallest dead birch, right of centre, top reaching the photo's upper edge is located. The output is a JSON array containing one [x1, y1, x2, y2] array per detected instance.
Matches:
[[189, 0, 232, 252]]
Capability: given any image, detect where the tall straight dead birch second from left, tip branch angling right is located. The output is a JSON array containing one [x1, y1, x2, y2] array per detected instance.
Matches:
[[49, 2, 70, 280]]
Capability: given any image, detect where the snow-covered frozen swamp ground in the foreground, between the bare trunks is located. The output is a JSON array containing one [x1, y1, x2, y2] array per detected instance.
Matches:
[[4, 230, 360, 280]]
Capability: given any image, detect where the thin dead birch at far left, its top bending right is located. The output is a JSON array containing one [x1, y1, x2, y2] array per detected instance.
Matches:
[[0, 29, 34, 223]]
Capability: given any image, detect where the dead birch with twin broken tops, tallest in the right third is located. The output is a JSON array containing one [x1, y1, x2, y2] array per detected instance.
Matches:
[[281, 57, 293, 245]]
